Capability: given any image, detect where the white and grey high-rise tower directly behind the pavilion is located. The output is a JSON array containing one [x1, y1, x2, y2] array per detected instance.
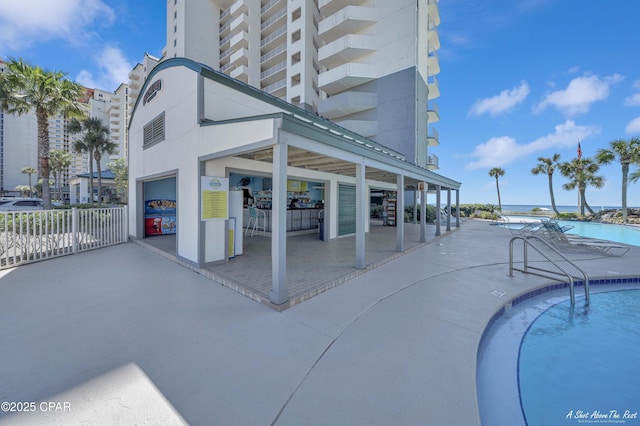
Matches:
[[160, 0, 440, 169]]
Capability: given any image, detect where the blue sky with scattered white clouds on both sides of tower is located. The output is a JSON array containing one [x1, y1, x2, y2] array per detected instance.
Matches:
[[0, 0, 640, 207]]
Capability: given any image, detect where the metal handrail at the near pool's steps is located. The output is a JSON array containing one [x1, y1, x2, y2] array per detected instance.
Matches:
[[509, 235, 589, 305]]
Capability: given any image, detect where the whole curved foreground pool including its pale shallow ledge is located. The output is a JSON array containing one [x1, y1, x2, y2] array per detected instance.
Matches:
[[477, 280, 640, 426]]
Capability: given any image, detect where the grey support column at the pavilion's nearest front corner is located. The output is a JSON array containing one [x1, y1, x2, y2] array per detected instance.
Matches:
[[269, 143, 289, 305]]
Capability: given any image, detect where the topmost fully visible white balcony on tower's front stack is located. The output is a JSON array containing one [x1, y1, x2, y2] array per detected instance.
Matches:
[[318, 6, 378, 43]]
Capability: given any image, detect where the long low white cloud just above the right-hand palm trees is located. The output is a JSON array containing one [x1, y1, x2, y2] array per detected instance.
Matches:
[[464, 120, 599, 170]]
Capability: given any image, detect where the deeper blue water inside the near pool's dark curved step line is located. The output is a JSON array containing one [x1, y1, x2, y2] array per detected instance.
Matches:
[[518, 290, 640, 425]]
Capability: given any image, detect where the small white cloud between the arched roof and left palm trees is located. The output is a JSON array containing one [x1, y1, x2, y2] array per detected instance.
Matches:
[[76, 46, 133, 91]]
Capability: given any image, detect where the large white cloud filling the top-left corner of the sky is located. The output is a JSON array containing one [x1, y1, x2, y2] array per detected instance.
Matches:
[[0, 0, 115, 51]]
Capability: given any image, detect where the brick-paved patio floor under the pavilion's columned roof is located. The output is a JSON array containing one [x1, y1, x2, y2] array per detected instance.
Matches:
[[139, 221, 456, 310]]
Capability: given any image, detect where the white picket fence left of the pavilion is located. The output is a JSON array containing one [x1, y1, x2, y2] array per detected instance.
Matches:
[[0, 207, 127, 269]]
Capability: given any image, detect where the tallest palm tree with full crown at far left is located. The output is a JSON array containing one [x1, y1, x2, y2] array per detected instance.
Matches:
[[0, 59, 84, 209]]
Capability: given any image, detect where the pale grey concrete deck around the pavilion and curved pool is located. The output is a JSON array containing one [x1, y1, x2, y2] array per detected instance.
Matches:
[[0, 220, 640, 426]]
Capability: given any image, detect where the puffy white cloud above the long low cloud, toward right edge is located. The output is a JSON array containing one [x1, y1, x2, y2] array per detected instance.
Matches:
[[534, 74, 624, 117]]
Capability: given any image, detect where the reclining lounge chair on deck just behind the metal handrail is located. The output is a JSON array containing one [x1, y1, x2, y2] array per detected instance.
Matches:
[[525, 220, 630, 256]]
